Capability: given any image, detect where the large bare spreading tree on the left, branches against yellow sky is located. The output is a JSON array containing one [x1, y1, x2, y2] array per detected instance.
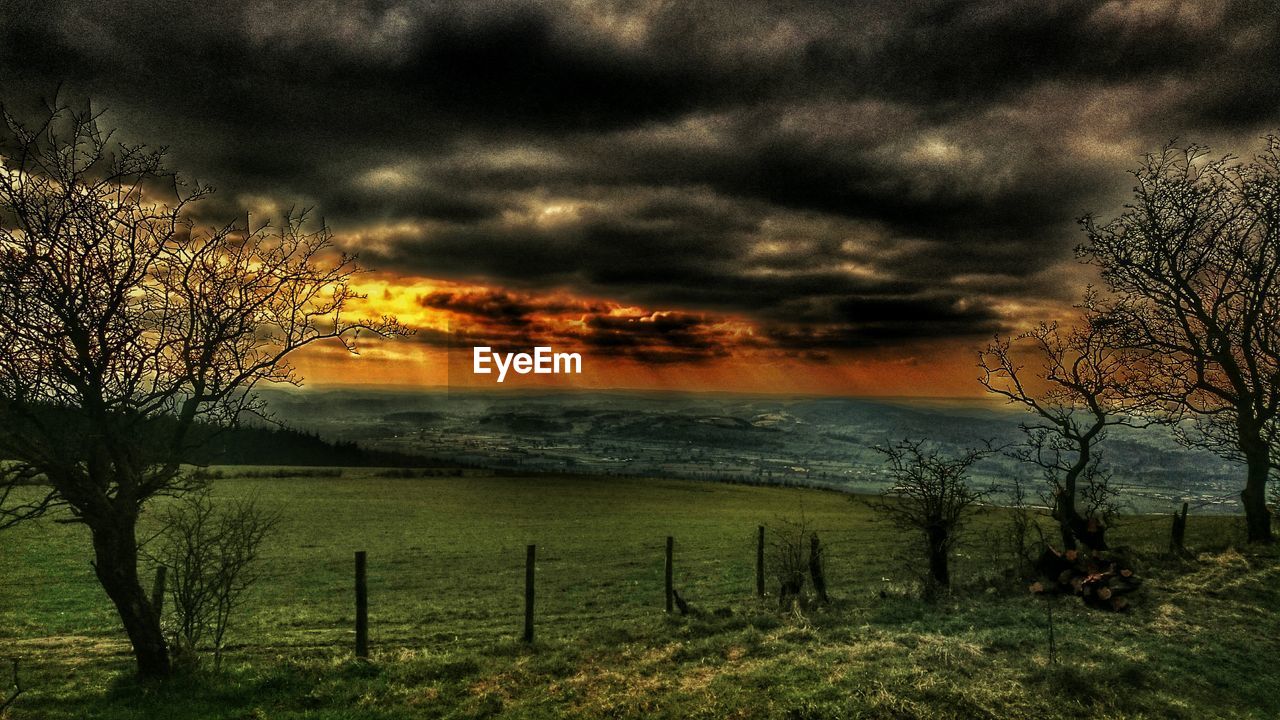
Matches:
[[0, 102, 403, 676]]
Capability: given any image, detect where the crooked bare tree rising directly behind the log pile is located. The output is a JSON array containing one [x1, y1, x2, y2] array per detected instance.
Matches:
[[978, 308, 1147, 550]]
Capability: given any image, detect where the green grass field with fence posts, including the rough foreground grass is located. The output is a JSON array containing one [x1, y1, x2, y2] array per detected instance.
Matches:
[[0, 470, 1280, 720]]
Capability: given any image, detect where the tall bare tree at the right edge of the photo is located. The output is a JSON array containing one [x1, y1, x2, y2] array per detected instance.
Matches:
[[1078, 136, 1280, 542]]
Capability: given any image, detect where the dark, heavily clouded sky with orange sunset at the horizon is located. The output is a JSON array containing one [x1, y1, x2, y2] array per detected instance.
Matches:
[[0, 0, 1280, 396]]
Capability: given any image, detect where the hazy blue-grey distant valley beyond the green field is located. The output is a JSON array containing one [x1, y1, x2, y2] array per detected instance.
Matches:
[[259, 389, 1239, 512]]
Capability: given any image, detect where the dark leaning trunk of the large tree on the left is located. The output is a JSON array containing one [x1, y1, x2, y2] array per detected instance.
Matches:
[[90, 512, 172, 679]]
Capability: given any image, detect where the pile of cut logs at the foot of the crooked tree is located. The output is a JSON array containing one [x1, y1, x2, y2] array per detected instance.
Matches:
[[1030, 547, 1142, 612]]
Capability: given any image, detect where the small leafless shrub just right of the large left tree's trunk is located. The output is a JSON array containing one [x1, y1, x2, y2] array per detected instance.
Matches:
[[151, 489, 280, 669]]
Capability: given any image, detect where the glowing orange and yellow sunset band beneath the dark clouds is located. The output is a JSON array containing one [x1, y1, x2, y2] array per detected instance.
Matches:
[[294, 273, 1049, 396]]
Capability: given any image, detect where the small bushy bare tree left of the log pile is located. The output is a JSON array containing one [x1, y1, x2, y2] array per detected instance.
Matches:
[[872, 439, 995, 588]]
